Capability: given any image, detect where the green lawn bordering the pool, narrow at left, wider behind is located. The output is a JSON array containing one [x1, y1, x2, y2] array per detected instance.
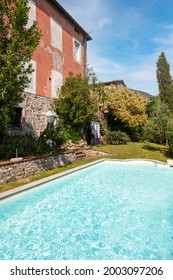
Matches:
[[0, 142, 171, 192]]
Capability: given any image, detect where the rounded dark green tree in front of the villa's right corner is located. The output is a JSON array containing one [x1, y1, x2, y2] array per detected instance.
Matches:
[[55, 73, 98, 140]]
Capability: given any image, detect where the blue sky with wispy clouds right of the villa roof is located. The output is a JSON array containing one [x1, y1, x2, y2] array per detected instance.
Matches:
[[58, 0, 173, 95]]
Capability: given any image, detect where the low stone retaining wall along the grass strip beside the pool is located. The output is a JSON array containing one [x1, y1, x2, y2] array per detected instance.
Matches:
[[0, 151, 76, 184]]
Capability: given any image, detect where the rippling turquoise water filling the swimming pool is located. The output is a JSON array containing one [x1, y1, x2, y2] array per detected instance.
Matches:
[[0, 161, 173, 260]]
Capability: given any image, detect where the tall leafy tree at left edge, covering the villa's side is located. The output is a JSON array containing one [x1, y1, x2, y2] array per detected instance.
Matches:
[[0, 0, 41, 134]]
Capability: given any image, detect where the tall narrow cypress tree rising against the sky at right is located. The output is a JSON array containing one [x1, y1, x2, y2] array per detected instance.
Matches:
[[157, 52, 173, 110]]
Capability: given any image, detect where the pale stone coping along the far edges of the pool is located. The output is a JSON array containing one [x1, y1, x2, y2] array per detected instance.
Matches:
[[0, 158, 168, 201]]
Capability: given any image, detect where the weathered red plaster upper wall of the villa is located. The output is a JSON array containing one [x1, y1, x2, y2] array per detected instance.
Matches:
[[32, 0, 85, 97]]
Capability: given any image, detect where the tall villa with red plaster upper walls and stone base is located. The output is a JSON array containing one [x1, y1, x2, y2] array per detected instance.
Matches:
[[12, 0, 92, 136]]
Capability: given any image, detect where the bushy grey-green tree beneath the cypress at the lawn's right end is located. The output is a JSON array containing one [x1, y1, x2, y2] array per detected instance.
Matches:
[[144, 97, 173, 144]]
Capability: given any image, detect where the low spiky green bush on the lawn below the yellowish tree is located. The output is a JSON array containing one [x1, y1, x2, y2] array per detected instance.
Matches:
[[104, 131, 130, 145]]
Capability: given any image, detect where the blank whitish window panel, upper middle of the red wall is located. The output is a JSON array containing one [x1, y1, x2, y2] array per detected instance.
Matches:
[[50, 18, 62, 51]]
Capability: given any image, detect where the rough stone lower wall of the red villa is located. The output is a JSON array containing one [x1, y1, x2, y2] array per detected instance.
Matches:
[[10, 93, 53, 136]]
